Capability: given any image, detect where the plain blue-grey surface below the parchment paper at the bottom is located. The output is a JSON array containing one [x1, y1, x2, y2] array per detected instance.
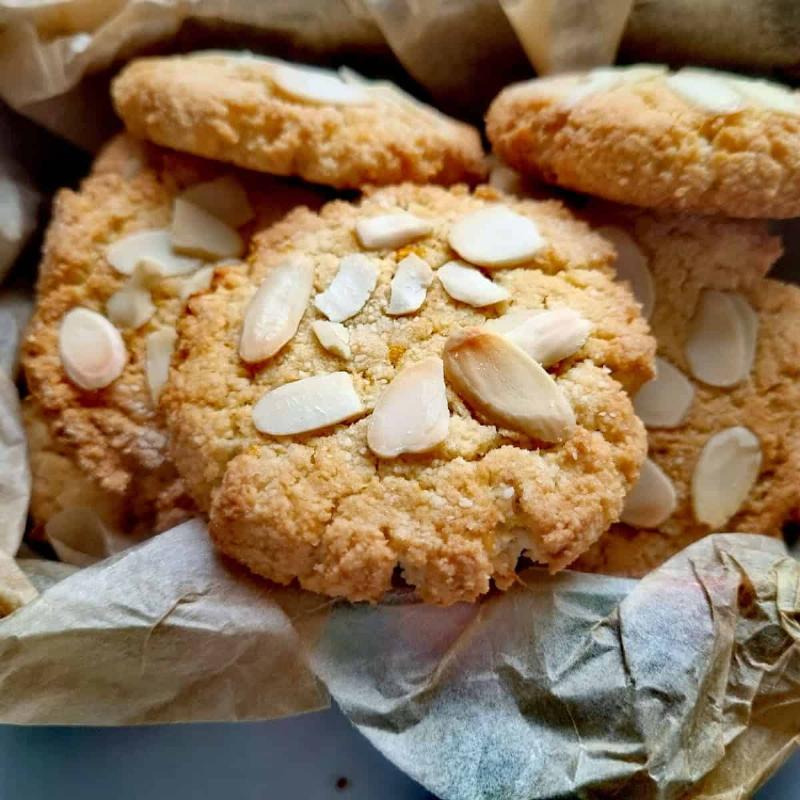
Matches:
[[0, 710, 800, 800]]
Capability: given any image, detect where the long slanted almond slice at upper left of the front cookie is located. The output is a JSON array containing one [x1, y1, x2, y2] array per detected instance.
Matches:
[[239, 255, 314, 364]]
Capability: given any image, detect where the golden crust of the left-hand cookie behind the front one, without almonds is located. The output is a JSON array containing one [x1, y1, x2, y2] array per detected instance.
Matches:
[[22, 137, 318, 531]]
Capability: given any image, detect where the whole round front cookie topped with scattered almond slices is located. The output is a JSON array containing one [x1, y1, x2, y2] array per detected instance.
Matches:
[[162, 184, 654, 604]]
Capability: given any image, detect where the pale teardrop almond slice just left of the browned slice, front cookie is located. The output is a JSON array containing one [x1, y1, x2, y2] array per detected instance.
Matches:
[[367, 356, 450, 458]]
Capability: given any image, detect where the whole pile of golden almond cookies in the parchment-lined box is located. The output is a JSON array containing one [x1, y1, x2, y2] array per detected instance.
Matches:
[[18, 52, 800, 604]]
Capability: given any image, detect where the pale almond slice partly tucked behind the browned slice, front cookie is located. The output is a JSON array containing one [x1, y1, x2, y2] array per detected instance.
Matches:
[[486, 308, 592, 367]]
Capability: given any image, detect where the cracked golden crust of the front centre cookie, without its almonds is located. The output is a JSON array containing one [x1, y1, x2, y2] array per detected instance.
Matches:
[[162, 184, 654, 603]]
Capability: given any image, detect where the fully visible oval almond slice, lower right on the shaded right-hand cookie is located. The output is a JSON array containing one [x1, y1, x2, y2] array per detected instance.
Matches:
[[692, 426, 761, 530]]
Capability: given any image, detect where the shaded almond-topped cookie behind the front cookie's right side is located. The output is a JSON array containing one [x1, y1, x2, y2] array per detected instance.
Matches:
[[576, 212, 800, 577]]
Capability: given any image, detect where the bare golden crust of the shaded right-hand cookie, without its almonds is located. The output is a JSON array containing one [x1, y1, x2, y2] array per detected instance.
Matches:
[[574, 209, 800, 577]]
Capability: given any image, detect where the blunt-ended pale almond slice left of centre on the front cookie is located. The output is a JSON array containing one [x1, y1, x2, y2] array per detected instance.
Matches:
[[253, 372, 364, 436]]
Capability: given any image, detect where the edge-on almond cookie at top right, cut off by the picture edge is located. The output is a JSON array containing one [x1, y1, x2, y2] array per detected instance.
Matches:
[[487, 65, 800, 218]]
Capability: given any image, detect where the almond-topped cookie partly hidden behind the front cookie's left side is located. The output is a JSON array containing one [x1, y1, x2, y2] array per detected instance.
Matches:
[[22, 137, 316, 533]]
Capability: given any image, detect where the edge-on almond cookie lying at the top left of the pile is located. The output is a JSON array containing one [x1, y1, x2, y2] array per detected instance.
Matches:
[[112, 51, 485, 189]]
